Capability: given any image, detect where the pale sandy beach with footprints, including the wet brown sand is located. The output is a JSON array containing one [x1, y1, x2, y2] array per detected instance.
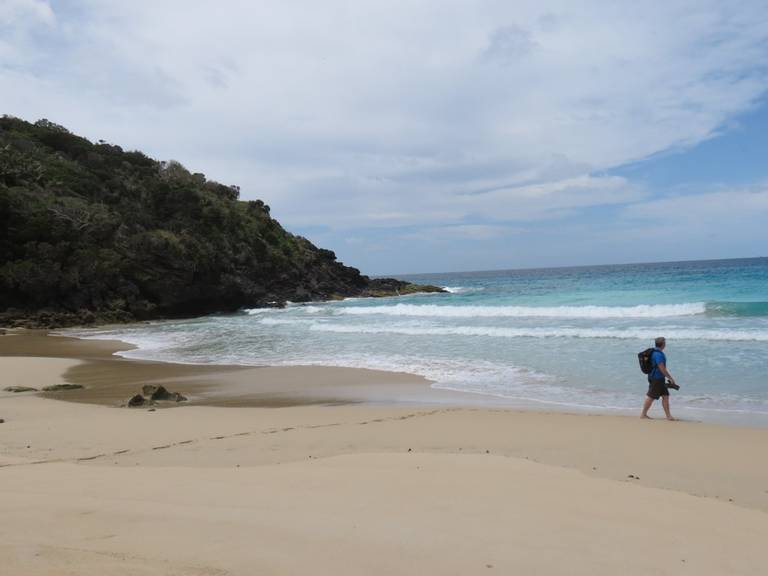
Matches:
[[0, 332, 768, 575]]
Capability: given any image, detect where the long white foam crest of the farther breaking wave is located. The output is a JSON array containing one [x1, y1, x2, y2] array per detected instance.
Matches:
[[338, 302, 706, 319]]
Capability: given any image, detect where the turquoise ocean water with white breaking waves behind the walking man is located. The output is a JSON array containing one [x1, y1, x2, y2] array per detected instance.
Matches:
[[67, 258, 768, 425]]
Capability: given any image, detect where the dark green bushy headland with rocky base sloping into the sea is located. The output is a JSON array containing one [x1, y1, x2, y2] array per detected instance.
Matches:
[[0, 116, 441, 327]]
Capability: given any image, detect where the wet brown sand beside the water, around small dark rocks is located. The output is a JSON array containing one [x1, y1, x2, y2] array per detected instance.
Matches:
[[0, 330, 482, 408]]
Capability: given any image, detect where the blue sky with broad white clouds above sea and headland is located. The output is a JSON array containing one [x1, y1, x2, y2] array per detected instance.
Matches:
[[0, 0, 768, 274]]
